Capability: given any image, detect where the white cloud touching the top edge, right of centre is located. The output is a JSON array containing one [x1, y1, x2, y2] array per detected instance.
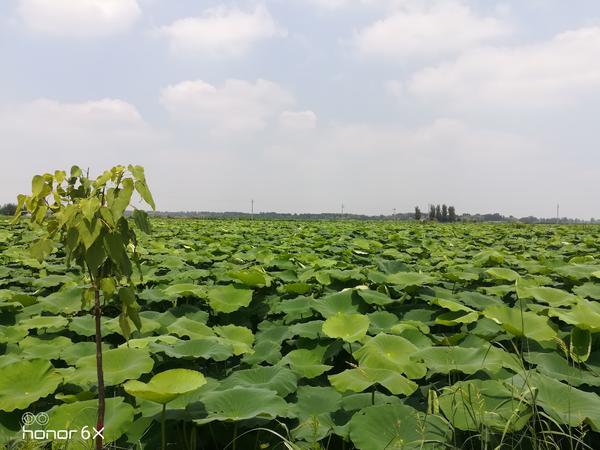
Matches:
[[355, 1, 509, 60]]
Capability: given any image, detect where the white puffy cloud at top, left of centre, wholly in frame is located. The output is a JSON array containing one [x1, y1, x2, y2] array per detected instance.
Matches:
[[161, 6, 285, 57]]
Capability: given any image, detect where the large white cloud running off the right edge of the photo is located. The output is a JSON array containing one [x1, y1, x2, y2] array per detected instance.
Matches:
[[406, 27, 600, 110]]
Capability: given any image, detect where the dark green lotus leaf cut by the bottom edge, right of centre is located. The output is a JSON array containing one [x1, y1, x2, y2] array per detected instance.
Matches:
[[350, 405, 451, 450]]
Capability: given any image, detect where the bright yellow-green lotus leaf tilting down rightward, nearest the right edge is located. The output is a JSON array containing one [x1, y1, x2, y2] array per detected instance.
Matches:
[[483, 305, 556, 342]]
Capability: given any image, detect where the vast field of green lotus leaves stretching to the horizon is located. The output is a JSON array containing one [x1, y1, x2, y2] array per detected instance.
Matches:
[[0, 219, 600, 450]]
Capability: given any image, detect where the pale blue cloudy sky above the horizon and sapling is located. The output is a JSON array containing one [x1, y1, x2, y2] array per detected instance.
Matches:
[[0, 0, 600, 219]]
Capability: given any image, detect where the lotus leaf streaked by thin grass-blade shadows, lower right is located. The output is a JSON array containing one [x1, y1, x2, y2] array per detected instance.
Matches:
[[439, 380, 532, 431]]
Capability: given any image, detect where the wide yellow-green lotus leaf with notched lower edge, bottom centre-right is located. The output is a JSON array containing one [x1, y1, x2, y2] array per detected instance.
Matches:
[[328, 367, 419, 396]]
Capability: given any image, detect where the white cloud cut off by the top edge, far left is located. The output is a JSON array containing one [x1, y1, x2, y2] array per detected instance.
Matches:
[[17, 0, 141, 38]]
